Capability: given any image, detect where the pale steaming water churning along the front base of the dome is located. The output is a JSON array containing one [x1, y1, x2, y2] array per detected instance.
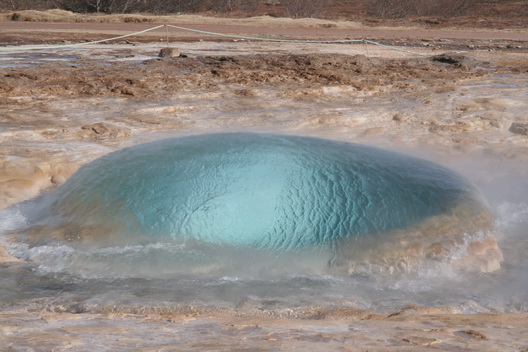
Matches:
[[0, 203, 528, 317]]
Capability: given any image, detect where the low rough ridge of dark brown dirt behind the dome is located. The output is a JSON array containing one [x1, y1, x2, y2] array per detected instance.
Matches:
[[0, 54, 482, 97]]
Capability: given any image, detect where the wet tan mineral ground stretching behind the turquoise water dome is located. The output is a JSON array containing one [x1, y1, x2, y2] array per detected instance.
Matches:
[[0, 42, 528, 209]]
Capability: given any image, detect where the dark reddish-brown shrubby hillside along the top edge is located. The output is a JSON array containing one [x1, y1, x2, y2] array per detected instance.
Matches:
[[0, 0, 528, 27]]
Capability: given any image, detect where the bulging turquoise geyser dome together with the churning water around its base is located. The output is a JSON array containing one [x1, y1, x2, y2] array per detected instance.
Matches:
[[0, 133, 525, 316]]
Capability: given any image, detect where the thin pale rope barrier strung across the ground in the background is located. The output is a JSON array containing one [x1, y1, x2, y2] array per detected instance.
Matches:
[[0, 24, 429, 56]]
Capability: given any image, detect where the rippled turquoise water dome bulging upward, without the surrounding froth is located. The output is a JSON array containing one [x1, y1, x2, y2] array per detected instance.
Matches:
[[32, 133, 486, 250]]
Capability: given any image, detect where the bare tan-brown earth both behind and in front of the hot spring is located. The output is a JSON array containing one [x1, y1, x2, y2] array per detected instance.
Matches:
[[0, 13, 528, 351]]
